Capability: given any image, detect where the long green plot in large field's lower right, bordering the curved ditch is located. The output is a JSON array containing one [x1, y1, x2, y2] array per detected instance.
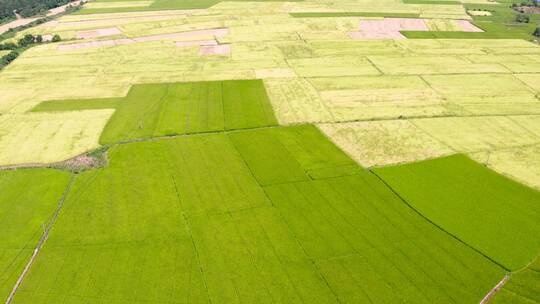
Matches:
[[265, 174, 503, 303]]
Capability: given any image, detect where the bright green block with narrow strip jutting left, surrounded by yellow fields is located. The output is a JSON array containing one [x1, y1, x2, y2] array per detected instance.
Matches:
[[34, 80, 277, 144]]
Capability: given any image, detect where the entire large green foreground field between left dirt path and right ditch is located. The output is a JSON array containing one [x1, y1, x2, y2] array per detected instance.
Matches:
[[9, 125, 503, 303]]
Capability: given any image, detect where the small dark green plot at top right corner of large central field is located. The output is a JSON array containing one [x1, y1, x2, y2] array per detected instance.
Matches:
[[229, 125, 362, 185]]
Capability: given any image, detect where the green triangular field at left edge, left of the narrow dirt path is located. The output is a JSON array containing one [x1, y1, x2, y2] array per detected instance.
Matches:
[[0, 169, 70, 300]]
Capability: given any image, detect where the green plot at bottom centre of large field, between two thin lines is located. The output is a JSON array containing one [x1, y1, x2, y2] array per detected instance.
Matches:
[[189, 208, 336, 303]]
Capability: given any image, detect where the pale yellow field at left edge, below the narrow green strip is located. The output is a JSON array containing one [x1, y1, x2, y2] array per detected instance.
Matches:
[[0, 110, 113, 165]]
